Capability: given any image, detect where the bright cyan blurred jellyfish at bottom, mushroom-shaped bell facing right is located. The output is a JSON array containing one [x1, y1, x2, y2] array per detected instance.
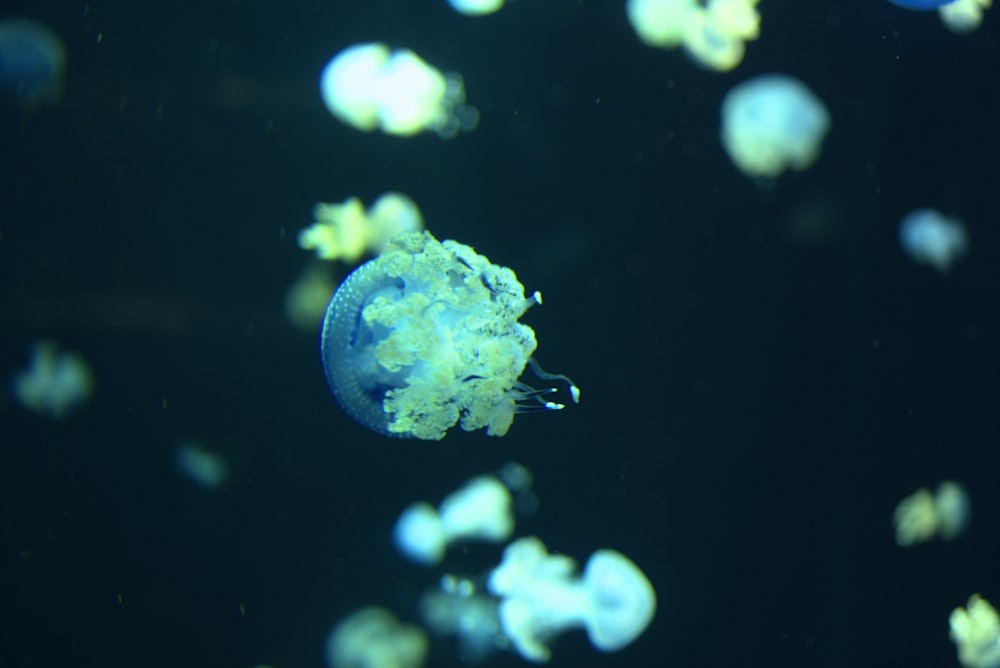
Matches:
[[488, 538, 656, 662]]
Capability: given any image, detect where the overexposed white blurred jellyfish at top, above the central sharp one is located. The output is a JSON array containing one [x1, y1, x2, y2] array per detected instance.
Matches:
[[319, 43, 479, 138]]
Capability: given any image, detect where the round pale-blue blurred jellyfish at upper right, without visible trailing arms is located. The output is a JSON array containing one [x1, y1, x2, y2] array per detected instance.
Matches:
[[721, 74, 830, 181]]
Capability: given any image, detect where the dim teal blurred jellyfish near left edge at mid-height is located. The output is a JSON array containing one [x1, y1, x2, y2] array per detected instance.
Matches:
[[11, 341, 94, 419]]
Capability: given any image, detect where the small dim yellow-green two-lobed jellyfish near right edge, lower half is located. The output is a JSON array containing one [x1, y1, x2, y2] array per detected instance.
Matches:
[[892, 480, 970, 547]]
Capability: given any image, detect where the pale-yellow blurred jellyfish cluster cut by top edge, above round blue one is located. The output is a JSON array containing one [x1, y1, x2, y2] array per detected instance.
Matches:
[[626, 0, 760, 72]]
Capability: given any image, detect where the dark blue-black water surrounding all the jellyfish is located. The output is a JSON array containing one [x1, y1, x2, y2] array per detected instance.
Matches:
[[0, 0, 1000, 668]]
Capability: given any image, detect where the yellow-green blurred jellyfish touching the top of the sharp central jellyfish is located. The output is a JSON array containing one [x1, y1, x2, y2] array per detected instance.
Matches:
[[298, 192, 424, 264]]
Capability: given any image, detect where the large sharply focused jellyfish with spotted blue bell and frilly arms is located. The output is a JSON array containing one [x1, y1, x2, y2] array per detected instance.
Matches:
[[320, 232, 579, 440]]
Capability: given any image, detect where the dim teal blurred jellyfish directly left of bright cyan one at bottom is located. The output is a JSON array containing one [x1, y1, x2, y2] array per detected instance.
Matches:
[[419, 575, 510, 663]]
